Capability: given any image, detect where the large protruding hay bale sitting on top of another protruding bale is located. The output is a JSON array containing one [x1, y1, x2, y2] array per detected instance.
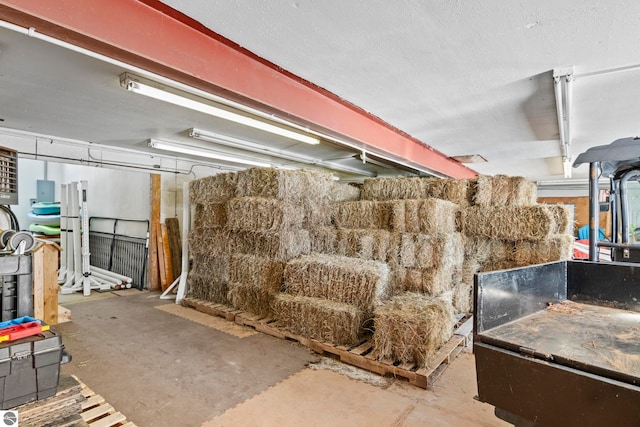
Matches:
[[284, 254, 389, 313]]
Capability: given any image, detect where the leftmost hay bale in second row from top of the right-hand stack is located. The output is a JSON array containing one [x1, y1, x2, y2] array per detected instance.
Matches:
[[333, 200, 405, 232]]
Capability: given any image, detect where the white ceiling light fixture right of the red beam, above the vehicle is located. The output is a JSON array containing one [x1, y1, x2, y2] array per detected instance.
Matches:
[[553, 67, 575, 178]]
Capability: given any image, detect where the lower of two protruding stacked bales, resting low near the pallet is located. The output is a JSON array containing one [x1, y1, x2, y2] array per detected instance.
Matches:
[[274, 294, 364, 346]]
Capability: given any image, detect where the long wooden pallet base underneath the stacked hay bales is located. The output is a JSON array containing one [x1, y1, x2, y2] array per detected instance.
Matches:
[[184, 298, 473, 388]]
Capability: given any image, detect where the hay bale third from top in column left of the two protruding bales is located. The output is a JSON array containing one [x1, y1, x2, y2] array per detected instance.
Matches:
[[229, 230, 311, 261]]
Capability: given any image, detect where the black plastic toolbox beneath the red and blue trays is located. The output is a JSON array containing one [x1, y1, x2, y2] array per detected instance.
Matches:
[[0, 329, 71, 410]]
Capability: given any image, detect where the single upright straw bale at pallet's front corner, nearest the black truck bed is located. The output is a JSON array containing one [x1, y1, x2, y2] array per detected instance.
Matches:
[[372, 292, 453, 366]]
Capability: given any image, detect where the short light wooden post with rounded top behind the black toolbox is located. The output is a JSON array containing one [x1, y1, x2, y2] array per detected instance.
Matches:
[[32, 243, 60, 325]]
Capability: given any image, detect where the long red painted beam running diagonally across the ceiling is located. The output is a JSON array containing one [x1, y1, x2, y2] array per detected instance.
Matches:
[[0, 0, 476, 178]]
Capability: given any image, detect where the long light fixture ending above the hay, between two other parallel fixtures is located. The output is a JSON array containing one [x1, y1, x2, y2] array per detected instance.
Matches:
[[188, 128, 377, 177]]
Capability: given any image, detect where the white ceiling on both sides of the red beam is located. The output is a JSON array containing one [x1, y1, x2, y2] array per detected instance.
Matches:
[[0, 0, 640, 181]]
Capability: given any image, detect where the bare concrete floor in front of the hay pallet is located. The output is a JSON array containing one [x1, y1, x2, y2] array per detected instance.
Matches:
[[57, 292, 506, 427]]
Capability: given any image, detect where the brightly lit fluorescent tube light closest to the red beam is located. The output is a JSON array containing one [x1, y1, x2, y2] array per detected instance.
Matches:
[[122, 76, 320, 144]]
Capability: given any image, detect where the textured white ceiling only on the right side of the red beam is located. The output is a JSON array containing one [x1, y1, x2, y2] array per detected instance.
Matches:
[[164, 0, 640, 180]]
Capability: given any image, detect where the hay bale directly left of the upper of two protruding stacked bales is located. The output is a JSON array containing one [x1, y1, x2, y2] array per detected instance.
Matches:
[[229, 254, 284, 290]]
